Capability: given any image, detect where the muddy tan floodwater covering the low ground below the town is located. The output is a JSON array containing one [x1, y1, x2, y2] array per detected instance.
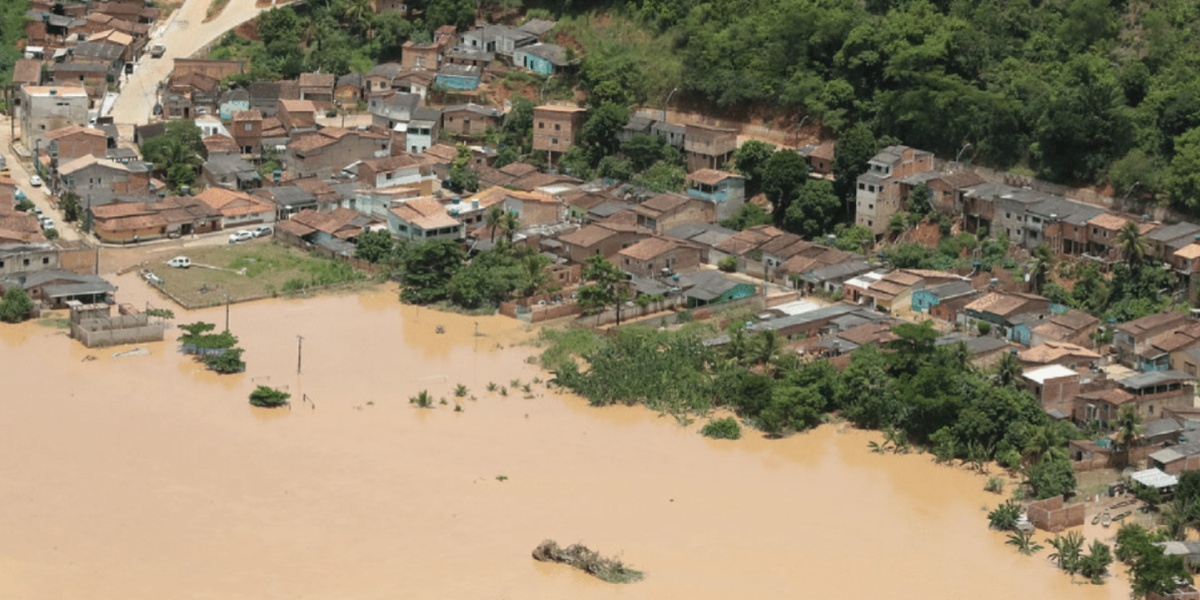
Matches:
[[0, 277, 1128, 600]]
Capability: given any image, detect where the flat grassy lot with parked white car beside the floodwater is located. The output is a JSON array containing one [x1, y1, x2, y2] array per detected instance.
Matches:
[[151, 241, 367, 308]]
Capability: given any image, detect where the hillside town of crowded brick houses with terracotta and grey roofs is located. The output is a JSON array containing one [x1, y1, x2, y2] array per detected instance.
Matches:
[[9, 0, 1200, 598]]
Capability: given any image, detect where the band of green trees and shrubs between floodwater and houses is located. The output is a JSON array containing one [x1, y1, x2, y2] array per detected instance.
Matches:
[[541, 320, 1078, 498]]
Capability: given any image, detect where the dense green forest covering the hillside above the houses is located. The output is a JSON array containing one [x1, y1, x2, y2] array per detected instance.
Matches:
[[537, 0, 1200, 208]]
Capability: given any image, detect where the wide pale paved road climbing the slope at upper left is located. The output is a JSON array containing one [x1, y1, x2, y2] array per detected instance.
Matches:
[[110, 0, 287, 126]]
